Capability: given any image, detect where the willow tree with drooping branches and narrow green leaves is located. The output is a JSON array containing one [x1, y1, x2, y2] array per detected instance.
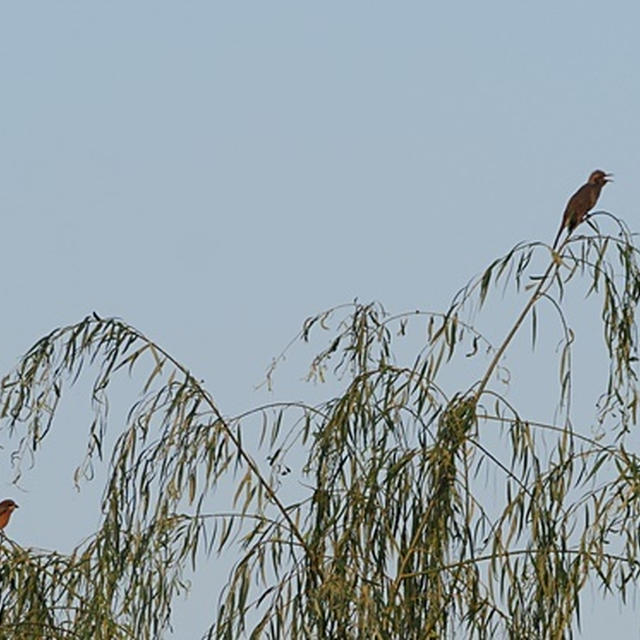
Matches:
[[0, 212, 640, 640]]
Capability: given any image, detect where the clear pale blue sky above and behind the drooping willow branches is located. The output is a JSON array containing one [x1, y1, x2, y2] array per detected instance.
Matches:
[[0, 0, 640, 639]]
